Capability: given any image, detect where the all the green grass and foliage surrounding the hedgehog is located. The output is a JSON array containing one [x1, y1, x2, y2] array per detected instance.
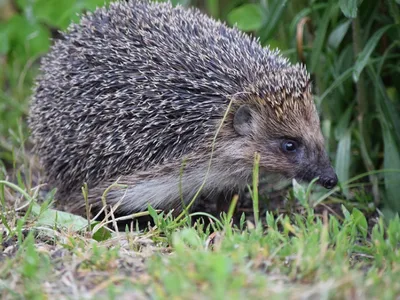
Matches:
[[0, 0, 400, 299]]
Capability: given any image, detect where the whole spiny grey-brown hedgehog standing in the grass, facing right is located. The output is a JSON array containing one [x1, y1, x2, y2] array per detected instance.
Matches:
[[29, 0, 338, 214]]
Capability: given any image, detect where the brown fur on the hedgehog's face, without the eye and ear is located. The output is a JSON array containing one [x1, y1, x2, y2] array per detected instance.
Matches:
[[228, 87, 337, 188]]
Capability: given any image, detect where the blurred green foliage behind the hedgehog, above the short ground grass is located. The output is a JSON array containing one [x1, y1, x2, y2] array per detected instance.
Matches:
[[0, 0, 400, 215]]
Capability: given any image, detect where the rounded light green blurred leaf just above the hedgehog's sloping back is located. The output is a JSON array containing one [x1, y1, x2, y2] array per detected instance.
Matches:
[[227, 4, 263, 31]]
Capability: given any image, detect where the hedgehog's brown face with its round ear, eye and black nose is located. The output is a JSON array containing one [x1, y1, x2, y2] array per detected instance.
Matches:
[[233, 102, 337, 189]]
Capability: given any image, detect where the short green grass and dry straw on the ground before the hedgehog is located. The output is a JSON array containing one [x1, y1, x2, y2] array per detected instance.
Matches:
[[0, 165, 400, 299]]
